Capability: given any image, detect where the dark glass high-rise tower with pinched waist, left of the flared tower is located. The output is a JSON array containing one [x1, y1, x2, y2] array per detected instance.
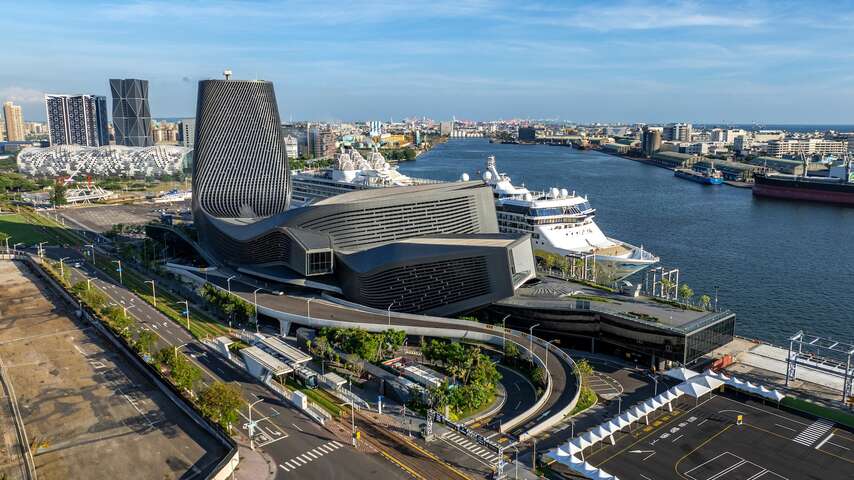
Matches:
[[110, 78, 154, 147]]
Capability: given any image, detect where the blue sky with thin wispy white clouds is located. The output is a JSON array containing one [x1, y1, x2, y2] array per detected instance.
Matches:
[[5, 0, 854, 124]]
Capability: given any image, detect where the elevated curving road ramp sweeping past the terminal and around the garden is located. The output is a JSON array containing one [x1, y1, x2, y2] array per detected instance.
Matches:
[[208, 274, 576, 435]]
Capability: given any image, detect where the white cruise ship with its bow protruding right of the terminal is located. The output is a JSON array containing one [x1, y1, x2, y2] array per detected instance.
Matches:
[[483, 156, 659, 281]]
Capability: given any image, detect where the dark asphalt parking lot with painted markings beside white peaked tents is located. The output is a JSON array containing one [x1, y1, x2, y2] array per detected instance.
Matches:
[[585, 393, 854, 480]]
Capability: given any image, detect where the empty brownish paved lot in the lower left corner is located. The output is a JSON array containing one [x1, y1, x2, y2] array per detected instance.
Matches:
[[0, 262, 225, 479]]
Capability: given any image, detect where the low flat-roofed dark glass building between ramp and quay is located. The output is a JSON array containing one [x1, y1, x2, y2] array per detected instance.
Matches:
[[485, 297, 736, 369]]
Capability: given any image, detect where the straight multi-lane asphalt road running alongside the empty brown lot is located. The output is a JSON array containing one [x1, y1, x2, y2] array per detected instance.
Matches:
[[48, 249, 410, 480]]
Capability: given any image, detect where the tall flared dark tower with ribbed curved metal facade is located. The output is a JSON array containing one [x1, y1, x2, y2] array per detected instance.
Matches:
[[193, 80, 291, 218]]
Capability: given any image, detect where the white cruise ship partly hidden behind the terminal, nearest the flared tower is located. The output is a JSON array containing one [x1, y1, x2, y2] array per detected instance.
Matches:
[[291, 149, 440, 207]]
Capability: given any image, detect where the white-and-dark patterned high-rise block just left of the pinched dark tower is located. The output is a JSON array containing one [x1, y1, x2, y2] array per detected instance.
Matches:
[[44, 94, 110, 147]]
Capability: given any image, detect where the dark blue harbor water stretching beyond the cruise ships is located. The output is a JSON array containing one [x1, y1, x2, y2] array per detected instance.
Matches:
[[400, 139, 854, 344]]
